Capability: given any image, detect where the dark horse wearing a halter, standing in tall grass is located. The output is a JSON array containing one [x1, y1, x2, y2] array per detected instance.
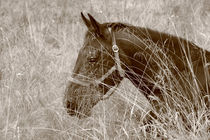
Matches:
[[64, 12, 210, 118]]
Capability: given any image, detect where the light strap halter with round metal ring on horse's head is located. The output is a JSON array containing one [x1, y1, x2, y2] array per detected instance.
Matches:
[[69, 27, 125, 100]]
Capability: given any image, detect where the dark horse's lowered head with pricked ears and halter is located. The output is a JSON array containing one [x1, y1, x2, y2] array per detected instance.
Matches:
[[64, 13, 126, 117]]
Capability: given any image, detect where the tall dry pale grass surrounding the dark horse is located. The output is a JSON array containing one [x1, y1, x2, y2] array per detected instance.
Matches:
[[0, 0, 210, 140]]
